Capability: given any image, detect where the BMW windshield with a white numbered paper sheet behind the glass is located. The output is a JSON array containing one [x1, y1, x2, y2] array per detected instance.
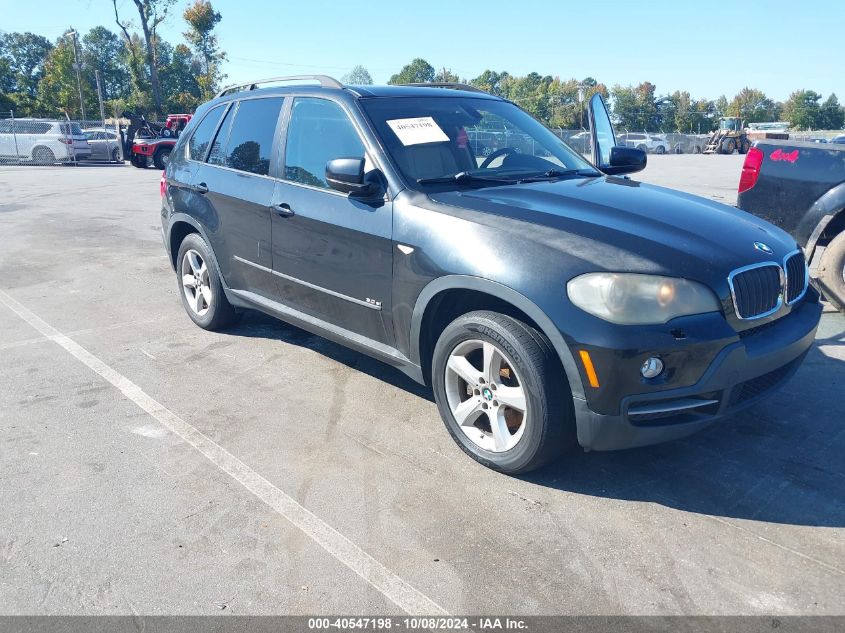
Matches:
[[360, 96, 598, 189]]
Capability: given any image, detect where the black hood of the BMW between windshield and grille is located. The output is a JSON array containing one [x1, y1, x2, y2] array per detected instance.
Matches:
[[429, 176, 797, 280]]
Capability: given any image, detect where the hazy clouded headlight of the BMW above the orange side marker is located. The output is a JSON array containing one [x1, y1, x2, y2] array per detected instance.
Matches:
[[566, 273, 719, 325]]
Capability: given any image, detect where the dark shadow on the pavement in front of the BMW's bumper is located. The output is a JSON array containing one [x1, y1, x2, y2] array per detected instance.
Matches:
[[523, 332, 845, 527]]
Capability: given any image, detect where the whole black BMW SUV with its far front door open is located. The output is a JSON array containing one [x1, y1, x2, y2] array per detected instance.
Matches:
[[161, 76, 821, 473]]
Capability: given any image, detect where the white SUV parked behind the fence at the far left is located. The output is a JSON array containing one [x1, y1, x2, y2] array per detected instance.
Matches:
[[0, 119, 91, 165]]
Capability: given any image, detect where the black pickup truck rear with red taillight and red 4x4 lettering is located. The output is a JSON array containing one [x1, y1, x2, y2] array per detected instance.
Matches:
[[737, 140, 845, 311]]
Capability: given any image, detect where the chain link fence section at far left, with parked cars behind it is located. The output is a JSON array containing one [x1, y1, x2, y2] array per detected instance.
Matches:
[[0, 112, 124, 166]]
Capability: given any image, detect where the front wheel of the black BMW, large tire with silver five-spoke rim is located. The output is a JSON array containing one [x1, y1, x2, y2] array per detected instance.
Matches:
[[432, 311, 575, 475]]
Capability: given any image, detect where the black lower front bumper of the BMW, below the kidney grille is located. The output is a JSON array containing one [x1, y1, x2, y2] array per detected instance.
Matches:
[[574, 291, 822, 450]]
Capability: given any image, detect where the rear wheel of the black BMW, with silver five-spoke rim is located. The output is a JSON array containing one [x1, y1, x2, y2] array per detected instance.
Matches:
[[176, 233, 237, 330]]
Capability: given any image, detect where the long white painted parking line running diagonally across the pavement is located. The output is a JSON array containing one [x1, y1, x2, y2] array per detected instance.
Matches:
[[0, 290, 447, 615]]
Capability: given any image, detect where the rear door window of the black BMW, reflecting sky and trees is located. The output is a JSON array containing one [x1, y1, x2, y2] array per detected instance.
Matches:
[[221, 97, 283, 176]]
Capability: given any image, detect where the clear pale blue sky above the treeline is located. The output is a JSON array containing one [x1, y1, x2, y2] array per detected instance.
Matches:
[[0, 0, 845, 101]]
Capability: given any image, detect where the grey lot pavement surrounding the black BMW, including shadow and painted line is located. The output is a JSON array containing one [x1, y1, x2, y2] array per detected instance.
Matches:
[[0, 156, 845, 615]]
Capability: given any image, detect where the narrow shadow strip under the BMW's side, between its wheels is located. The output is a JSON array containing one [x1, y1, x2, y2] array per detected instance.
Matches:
[[226, 310, 439, 400]]
